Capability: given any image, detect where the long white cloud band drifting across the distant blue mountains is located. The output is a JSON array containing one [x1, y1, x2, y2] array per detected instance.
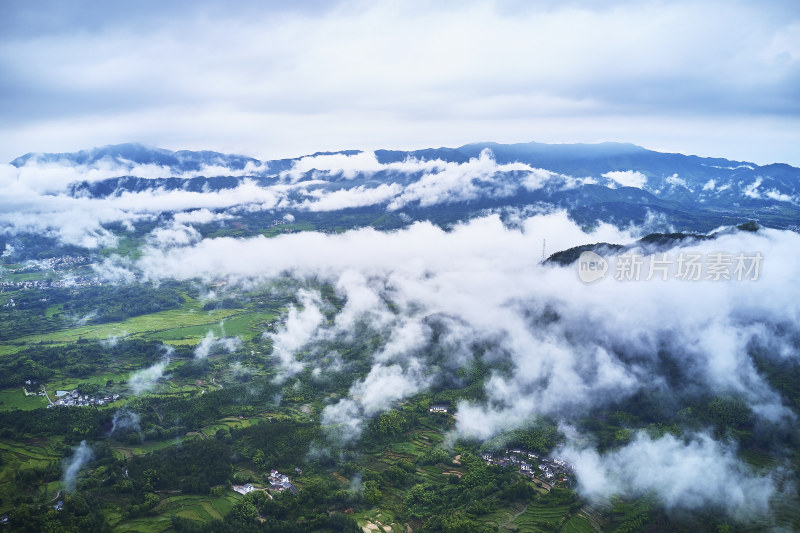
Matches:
[[0, 150, 616, 248]]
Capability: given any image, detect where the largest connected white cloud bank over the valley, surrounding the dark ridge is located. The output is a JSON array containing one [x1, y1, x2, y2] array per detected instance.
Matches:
[[119, 212, 800, 462]]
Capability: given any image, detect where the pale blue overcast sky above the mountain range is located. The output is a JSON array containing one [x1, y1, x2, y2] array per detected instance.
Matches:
[[0, 0, 800, 166]]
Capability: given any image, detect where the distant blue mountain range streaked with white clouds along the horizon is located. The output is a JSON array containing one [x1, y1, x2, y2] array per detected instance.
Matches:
[[11, 143, 800, 231]]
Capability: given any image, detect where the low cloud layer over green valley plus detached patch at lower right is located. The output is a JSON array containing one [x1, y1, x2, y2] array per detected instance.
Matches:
[[90, 212, 800, 509]]
